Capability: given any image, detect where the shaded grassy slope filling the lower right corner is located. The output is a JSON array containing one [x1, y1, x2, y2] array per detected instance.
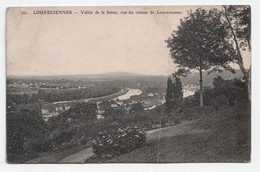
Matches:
[[102, 104, 251, 162]]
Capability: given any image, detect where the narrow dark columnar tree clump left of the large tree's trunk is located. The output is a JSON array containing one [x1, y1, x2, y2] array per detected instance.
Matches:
[[165, 75, 183, 112]]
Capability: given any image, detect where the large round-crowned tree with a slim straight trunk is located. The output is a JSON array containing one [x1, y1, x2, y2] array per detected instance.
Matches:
[[166, 8, 235, 107]]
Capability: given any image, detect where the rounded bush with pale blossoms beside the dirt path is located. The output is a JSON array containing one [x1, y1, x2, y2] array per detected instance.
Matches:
[[93, 126, 145, 158]]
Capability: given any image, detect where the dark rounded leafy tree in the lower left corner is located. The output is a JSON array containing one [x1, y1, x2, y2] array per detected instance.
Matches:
[[6, 109, 47, 162]]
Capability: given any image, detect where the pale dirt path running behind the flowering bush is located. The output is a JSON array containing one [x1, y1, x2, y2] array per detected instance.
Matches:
[[60, 120, 199, 163]]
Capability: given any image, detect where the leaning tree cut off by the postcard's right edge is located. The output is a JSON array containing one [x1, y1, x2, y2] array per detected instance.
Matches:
[[223, 5, 251, 101]]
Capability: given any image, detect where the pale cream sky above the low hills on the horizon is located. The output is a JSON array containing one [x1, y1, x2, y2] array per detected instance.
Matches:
[[6, 6, 250, 76]]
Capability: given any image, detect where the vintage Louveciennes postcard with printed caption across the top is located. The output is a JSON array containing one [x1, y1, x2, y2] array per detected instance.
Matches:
[[6, 5, 251, 164]]
